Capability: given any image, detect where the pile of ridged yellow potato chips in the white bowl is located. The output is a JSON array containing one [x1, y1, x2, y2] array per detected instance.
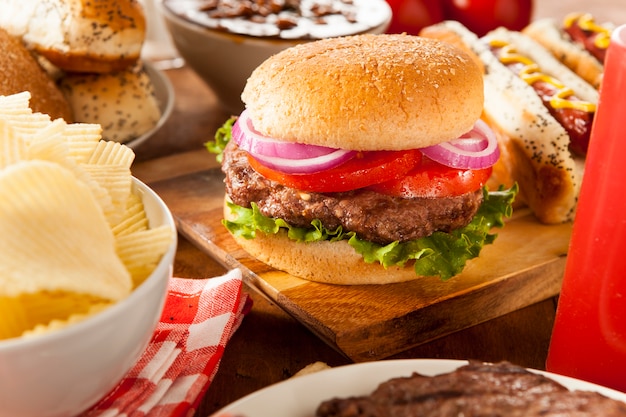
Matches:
[[0, 93, 173, 340]]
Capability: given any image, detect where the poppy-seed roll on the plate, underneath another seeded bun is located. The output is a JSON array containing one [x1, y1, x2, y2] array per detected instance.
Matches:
[[59, 64, 161, 143]]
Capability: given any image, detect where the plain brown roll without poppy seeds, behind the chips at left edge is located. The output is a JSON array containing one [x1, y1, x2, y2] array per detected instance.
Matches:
[[0, 29, 74, 122]]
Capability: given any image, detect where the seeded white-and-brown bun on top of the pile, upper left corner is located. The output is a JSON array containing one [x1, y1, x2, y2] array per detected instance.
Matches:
[[0, 0, 146, 72]]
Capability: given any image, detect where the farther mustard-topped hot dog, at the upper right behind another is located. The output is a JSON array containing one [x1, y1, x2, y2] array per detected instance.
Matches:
[[523, 12, 614, 88]]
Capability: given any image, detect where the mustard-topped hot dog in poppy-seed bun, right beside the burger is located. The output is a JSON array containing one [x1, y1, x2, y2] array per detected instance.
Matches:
[[420, 21, 598, 224]]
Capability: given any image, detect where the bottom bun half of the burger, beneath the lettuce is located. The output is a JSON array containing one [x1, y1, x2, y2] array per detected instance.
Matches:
[[224, 200, 421, 285]]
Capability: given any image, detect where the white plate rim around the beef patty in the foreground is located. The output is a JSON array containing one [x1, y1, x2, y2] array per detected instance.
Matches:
[[208, 359, 626, 417]]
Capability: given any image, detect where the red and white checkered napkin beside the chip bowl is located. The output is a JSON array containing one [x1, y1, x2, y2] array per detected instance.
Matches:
[[83, 269, 252, 417]]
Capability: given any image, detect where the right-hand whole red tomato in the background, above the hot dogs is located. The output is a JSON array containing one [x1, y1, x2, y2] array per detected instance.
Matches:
[[442, 0, 533, 36]]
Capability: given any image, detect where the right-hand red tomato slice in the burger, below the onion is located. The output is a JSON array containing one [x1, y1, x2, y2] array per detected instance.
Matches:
[[369, 156, 492, 198]]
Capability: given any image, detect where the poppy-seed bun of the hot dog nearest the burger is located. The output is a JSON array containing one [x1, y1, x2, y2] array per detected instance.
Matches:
[[421, 22, 598, 224]]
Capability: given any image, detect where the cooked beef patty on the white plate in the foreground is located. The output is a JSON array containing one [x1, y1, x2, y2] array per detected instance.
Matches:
[[315, 362, 626, 417]]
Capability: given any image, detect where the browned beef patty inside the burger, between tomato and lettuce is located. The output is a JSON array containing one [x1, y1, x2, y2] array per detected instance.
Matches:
[[222, 141, 483, 245]]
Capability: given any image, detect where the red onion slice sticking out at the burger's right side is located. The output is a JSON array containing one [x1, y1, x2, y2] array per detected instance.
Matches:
[[420, 120, 500, 169]]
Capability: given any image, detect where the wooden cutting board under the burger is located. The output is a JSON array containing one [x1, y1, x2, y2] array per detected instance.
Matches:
[[150, 168, 571, 362]]
